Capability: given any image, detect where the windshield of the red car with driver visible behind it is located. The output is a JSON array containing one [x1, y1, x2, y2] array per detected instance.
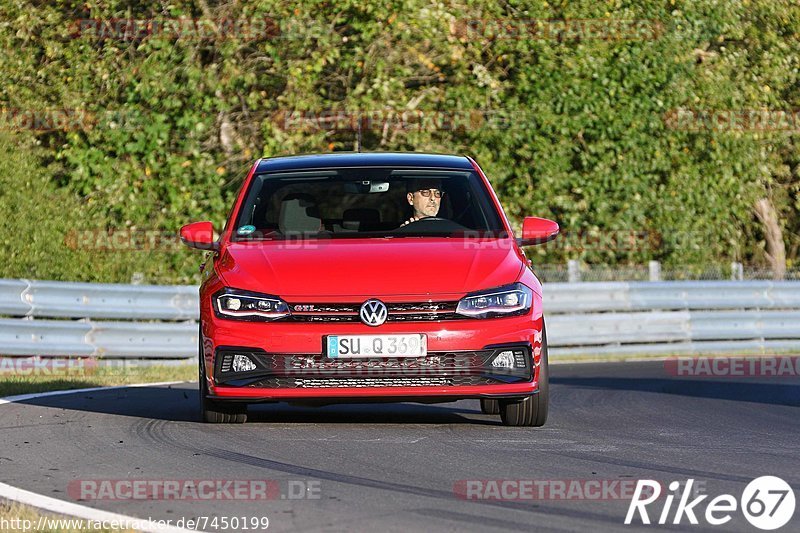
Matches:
[[232, 168, 507, 241]]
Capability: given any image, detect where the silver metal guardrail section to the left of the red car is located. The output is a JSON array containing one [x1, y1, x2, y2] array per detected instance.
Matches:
[[0, 279, 199, 359]]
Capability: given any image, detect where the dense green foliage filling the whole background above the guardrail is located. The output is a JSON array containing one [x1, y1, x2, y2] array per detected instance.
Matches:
[[0, 0, 800, 282]]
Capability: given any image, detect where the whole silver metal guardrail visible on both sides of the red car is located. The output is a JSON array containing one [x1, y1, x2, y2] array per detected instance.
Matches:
[[0, 280, 800, 359]]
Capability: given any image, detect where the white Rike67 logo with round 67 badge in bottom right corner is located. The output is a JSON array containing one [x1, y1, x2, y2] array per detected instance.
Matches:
[[625, 476, 795, 531]]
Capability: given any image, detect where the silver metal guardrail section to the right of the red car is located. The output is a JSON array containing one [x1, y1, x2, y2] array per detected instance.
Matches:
[[544, 281, 800, 355]]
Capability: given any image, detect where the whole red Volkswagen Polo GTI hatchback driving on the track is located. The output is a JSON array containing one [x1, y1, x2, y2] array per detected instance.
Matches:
[[181, 153, 558, 426]]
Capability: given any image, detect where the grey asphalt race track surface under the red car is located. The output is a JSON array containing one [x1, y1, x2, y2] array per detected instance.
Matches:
[[0, 361, 800, 532]]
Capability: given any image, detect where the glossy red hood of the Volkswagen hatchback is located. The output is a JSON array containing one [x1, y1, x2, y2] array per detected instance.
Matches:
[[215, 238, 524, 298]]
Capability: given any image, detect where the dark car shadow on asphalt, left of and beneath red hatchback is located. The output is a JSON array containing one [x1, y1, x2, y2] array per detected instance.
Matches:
[[14, 383, 500, 425]]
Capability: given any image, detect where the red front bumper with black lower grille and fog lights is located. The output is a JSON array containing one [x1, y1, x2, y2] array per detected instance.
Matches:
[[201, 294, 542, 402]]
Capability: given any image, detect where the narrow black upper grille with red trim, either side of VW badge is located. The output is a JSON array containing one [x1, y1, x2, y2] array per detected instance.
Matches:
[[284, 302, 456, 322]]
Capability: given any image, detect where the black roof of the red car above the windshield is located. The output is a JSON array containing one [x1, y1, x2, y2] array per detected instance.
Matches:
[[256, 152, 473, 172]]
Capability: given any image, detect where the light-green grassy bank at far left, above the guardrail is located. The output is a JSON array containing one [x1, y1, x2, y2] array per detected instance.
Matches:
[[0, 132, 198, 284]]
